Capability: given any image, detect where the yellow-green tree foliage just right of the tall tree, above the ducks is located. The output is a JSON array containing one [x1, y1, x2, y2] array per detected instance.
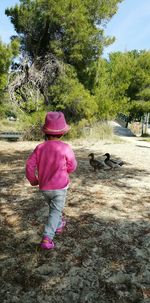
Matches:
[[94, 59, 128, 120]]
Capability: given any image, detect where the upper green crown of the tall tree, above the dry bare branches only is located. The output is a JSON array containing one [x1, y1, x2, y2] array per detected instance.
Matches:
[[6, 0, 122, 74]]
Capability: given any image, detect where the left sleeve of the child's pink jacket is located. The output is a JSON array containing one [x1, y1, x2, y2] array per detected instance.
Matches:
[[26, 149, 39, 186]]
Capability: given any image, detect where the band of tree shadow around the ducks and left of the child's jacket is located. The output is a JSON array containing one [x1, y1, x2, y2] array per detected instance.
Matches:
[[0, 149, 149, 195]]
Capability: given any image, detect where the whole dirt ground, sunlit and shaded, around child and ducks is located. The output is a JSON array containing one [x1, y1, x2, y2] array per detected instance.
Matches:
[[0, 125, 150, 303]]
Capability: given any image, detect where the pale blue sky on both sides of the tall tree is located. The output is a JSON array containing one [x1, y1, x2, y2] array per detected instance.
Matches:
[[0, 0, 150, 57]]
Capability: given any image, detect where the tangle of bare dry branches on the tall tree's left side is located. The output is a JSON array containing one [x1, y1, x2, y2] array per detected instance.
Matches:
[[8, 54, 62, 104]]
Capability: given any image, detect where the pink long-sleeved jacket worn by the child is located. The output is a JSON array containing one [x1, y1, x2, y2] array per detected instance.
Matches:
[[26, 140, 77, 190]]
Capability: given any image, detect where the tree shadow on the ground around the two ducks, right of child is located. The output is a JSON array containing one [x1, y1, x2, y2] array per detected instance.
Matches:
[[71, 150, 149, 190]]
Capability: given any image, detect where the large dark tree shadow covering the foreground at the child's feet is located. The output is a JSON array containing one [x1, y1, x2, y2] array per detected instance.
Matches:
[[1, 211, 150, 303]]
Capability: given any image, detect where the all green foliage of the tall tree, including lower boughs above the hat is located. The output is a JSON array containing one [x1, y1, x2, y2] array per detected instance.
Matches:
[[5, 0, 122, 126]]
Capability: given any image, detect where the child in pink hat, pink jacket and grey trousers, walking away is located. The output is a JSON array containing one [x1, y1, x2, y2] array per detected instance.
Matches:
[[26, 112, 77, 249]]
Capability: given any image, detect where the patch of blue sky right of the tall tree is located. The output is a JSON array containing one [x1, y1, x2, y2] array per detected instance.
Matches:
[[104, 0, 150, 55]]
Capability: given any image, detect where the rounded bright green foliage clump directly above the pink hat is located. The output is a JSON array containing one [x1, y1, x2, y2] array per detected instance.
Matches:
[[47, 66, 97, 122]]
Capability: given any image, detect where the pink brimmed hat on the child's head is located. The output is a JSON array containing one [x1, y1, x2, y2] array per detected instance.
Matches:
[[42, 112, 70, 135]]
